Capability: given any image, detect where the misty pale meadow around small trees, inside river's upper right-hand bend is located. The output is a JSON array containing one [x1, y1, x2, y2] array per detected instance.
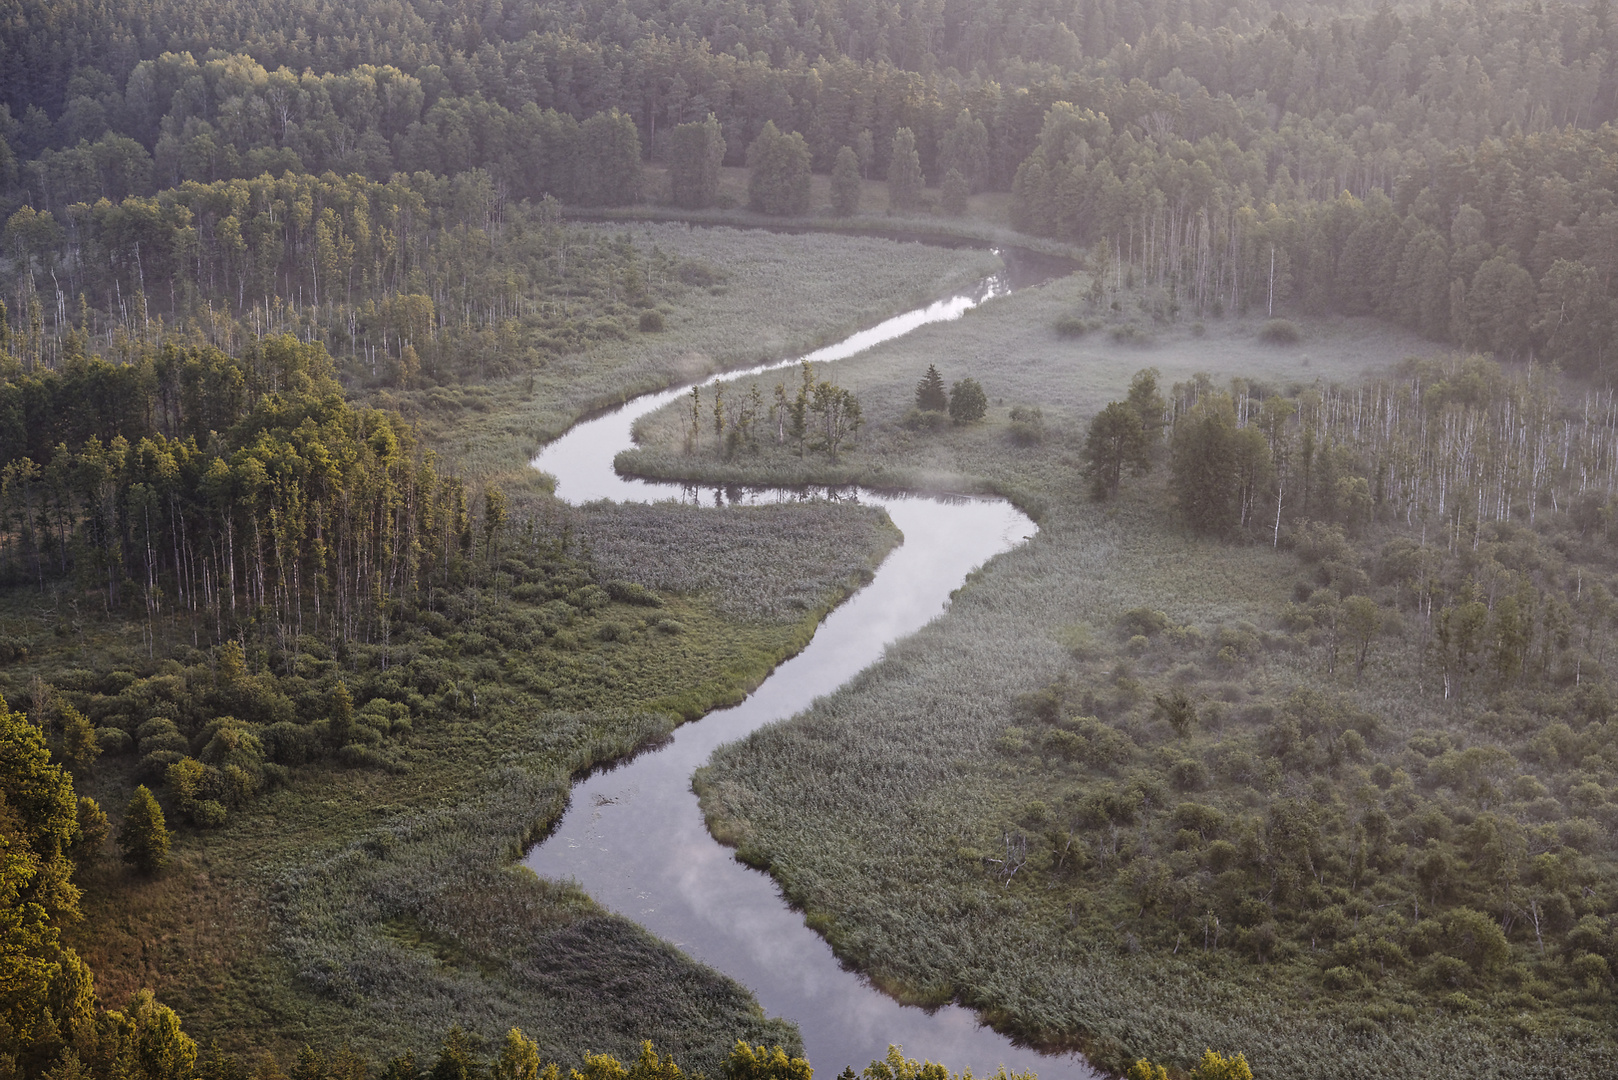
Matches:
[[618, 268, 1429, 512]]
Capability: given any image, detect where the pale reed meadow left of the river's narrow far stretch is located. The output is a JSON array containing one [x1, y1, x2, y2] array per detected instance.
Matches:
[[375, 222, 1000, 487]]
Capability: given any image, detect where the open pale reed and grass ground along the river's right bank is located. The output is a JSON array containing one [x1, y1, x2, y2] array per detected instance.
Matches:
[[620, 265, 1615, 1077]]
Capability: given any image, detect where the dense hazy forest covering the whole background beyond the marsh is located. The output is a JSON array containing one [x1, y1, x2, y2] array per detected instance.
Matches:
[[9, 3, 1618, 380]]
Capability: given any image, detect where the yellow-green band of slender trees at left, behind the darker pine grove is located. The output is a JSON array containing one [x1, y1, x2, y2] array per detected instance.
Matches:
[[0, 170, 684, 387]]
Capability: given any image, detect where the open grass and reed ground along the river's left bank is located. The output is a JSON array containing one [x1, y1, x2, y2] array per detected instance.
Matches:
[[34, 225, 998, 1070]]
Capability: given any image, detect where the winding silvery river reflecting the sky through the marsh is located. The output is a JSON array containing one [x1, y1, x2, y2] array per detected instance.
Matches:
[[524, 253, 1097, 1080]]
